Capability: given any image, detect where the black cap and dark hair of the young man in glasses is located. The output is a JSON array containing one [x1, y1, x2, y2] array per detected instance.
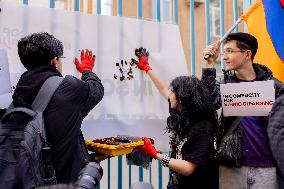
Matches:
[[224, 32, 258, 60]]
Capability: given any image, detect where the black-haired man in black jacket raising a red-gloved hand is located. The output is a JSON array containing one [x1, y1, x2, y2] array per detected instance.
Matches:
[[13, 33, 104, 183]]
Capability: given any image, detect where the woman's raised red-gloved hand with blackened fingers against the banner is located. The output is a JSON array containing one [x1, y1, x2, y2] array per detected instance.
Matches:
[[131, 47, 152, 73]]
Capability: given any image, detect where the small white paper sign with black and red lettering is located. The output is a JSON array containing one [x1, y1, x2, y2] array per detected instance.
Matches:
[[220, 80, 275, 116]]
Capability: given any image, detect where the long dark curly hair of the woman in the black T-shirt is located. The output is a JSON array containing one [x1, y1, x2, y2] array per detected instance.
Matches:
[[167, 76, 217, 139]]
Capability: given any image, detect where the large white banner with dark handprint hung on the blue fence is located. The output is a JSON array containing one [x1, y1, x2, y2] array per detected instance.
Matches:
[[0, 2, 187, 151]]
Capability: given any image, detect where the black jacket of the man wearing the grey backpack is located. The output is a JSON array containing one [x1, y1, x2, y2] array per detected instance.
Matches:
[[13, 66, 104, 183]]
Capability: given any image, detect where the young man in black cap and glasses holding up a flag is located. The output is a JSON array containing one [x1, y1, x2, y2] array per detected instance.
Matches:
[[202, 32, 282, 189]]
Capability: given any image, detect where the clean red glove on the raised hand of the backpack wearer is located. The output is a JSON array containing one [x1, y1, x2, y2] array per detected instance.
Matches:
[[75, 50, 96, 73]]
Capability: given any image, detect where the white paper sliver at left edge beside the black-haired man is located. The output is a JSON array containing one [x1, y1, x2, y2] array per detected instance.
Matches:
[[0, 49, 11, 95]]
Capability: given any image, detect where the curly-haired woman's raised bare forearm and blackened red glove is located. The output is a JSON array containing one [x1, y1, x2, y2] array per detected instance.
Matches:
[[132, 47, 170, 99]]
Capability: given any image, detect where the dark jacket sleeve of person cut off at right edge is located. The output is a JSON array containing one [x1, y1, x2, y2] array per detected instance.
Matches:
[[267, 86, 284, 178]]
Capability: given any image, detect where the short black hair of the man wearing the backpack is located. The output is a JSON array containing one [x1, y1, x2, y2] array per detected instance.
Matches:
[[18, 32, 63, 70]]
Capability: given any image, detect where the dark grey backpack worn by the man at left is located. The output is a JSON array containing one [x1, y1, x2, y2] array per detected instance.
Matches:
[[0, 76, 63, 189]]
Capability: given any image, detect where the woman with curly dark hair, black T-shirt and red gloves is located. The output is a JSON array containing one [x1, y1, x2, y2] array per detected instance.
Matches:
[[133, 47, 218, 189]]
